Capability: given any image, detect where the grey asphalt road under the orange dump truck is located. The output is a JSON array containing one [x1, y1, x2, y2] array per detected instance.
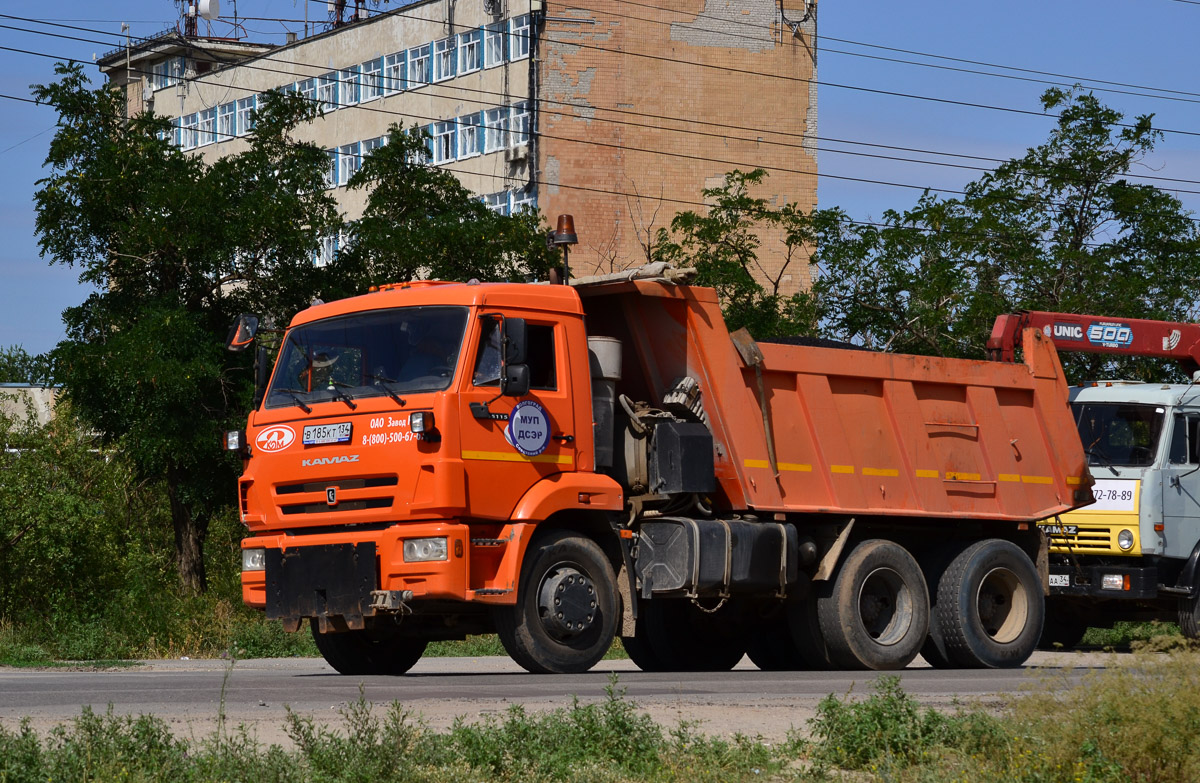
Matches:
[[0, 653, 1123, 743]]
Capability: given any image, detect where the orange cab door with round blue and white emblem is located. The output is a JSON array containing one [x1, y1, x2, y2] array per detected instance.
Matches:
[[460, 313, 578, 520]]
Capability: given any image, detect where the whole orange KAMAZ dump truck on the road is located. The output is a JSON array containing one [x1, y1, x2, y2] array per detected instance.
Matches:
[[227, 270, 1091, 674]]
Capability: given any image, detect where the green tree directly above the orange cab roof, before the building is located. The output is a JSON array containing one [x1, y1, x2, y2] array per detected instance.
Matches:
[[335, 125, 562, 292]]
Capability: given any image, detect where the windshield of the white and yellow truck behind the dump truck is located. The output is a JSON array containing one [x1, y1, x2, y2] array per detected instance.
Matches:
[[1073, 402, 1165, 467]]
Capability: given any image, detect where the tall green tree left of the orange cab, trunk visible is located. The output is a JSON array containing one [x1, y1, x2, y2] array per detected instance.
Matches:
[[35, 65, 341, 592]]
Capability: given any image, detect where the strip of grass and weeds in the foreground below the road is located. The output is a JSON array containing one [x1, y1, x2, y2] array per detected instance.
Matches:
[[7, 646, 1200, 783]]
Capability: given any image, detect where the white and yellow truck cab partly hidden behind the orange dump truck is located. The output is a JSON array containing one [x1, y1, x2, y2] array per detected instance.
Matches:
[[1040, 381, 1200, 647]]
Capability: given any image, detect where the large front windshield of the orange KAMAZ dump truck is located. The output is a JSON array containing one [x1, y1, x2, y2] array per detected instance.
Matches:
[[266, 307, 467, 408]]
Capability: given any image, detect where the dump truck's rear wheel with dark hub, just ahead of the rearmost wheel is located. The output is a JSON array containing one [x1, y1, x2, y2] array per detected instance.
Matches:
[[817, 539, 929, 669]]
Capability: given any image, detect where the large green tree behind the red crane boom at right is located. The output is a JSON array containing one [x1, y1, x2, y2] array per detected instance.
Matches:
[[810, 89, 1200, 378]]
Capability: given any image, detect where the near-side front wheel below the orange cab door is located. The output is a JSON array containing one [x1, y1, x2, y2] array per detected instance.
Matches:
[[496, 531, 619, 674]]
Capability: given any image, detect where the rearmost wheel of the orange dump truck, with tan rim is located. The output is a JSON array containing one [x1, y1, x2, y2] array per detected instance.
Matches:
[[931, 538, 1045, 669]]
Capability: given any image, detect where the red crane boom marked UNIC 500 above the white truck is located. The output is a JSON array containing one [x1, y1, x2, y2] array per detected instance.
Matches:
[[988, 310, 1200, 375]]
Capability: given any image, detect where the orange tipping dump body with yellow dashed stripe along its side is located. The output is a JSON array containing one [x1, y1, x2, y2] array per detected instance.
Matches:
[[582, 281, 1090, 522]]
